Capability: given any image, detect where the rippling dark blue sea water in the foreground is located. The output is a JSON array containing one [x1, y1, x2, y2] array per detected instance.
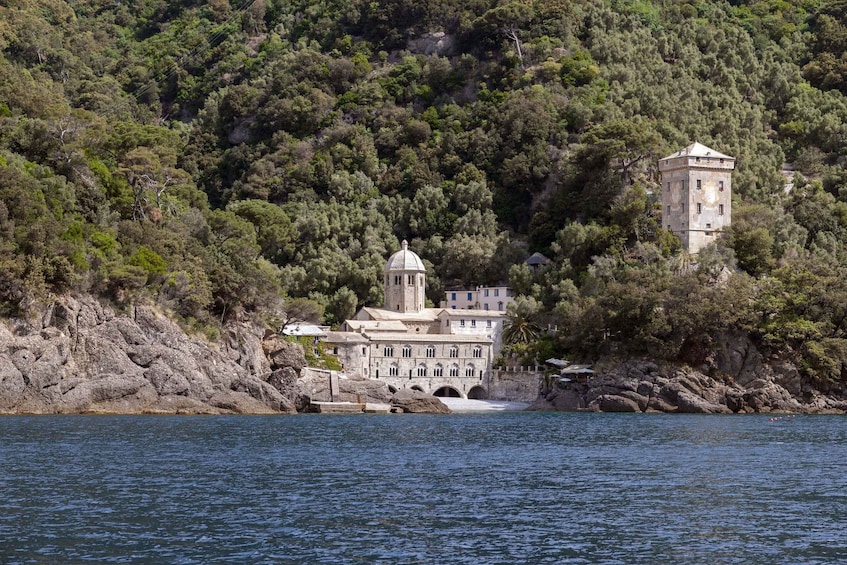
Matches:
[[0, 413, 847, 564]]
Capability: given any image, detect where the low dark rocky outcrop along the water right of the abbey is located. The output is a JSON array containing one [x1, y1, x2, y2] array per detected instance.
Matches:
[[530, 360, 847, 414]]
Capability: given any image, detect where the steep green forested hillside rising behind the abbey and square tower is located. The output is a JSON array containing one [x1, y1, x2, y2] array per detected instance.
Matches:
[[0, 0, 847, 383]]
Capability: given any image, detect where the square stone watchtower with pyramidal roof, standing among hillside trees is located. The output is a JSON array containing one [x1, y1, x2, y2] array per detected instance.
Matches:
[[659, 142, 735, 254]]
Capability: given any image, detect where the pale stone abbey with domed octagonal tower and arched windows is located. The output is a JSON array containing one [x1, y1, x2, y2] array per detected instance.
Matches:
[[324, 241, 505, 398]]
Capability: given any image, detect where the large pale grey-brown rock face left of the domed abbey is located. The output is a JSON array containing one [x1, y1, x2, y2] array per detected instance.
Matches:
[[0, 297, 302, 414]]
